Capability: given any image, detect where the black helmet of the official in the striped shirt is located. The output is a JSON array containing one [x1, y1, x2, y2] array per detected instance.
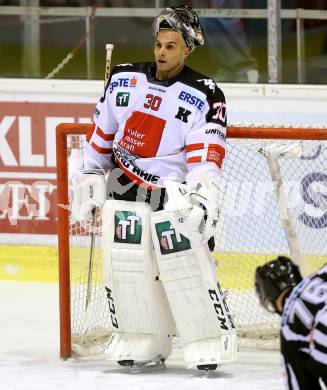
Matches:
[[255, 256, 302, 312]]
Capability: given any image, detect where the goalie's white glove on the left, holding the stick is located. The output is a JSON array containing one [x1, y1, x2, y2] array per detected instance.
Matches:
[[71, 169, 106, 223]]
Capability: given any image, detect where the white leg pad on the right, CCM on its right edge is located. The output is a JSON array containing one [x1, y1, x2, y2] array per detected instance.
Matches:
[[151, 210, 237, 368]]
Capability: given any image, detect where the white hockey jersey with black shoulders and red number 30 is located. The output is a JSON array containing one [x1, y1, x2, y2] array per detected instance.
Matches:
[[86, 63, 226, 189]]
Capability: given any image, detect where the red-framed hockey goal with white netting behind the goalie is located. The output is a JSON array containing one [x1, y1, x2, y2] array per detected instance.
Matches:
[[56, 123, 327, 359]]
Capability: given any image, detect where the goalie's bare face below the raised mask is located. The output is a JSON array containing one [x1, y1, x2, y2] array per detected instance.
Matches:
[[154, 30, 190, 80]]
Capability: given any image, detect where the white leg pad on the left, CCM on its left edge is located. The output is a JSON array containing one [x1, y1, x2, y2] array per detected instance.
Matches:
[[102, 200, 175, 362]]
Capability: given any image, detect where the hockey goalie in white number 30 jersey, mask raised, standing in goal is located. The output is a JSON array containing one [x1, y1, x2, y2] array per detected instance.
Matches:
[[70, 6, 236, 370]]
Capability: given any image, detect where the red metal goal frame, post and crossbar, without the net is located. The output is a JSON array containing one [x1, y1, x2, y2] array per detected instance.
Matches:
[[56, 123, 327, 360]]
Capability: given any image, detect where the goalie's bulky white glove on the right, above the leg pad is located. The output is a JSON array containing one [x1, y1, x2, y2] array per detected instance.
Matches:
[[165, 172, 219, 245]]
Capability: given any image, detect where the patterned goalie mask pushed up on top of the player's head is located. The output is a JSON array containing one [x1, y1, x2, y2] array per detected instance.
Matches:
[[152, 5, 204, 52]]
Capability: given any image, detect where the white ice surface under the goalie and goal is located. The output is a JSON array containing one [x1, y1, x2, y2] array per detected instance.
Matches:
[[0, 281, 285, 390]]
